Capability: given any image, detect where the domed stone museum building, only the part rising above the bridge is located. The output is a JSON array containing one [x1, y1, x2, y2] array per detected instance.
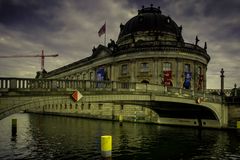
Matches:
[[44, 6, 210, 90]]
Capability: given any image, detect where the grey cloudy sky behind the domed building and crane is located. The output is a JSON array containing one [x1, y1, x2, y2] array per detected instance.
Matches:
[[0, 0, 240, 88]]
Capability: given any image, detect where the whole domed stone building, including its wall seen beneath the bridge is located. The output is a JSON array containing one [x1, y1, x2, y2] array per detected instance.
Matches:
[[32, 5, 215, 126]]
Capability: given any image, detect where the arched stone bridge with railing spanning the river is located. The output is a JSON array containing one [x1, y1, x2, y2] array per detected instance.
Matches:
[[0, 78, 236, 128]]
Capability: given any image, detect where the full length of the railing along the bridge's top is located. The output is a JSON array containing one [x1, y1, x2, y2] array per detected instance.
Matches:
[[0, 78, 221, 103]]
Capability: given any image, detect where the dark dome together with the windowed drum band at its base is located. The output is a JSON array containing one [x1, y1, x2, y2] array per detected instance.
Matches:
[[117, 5, 183, 45]]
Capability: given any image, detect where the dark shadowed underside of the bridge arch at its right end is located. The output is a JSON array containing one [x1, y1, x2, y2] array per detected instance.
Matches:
[[110, 100, 222, 128]]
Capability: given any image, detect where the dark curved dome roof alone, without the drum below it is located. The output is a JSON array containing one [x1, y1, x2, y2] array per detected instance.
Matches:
[[118, 5, 182, 38]]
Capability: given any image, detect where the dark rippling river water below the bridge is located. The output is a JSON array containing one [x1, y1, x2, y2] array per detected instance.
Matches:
[[0, 113, 240, 160]]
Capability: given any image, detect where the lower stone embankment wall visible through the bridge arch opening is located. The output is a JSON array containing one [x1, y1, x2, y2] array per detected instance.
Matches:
[[27, 100, 159, 123]]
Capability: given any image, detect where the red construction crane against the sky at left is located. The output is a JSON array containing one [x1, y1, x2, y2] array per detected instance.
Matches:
[[0, 50, 58, 71]]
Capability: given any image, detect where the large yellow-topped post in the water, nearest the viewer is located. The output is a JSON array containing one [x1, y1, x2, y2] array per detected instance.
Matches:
[[101, 135, 112, 157]]
